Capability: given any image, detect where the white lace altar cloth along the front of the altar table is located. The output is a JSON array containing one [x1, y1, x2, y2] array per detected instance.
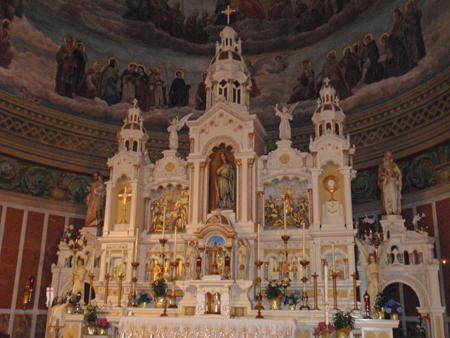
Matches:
[[119, 316, 297, 338]]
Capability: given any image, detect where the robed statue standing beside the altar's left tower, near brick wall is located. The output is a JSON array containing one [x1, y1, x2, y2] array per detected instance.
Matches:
[[85, 171, 106, 227]]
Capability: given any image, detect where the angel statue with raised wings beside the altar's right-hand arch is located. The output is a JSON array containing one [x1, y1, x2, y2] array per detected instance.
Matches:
[[355, 239, 389, 304]]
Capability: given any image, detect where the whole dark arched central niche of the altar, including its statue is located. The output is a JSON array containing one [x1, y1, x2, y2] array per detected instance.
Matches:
[[209, 144, 236, 211]]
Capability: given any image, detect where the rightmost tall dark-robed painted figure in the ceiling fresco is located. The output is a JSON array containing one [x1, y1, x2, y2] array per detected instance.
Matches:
[[405, 0, 426, 63]]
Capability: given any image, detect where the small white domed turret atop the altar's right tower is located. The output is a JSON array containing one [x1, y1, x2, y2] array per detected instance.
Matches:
[[312, 78, 345, 137]]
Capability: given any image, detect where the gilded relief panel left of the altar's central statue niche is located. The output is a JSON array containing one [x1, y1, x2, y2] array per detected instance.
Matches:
[[148, 184, 189, 233]]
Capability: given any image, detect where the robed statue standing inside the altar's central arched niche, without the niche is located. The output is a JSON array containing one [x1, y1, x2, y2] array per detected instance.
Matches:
[[214, 151, 235, 209]]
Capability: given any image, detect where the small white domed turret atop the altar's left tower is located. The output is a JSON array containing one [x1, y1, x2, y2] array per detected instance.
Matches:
[[117, 99, 148, 153]]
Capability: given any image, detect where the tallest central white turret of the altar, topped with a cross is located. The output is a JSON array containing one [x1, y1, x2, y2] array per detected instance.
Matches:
[[205, 9, 251, 114]]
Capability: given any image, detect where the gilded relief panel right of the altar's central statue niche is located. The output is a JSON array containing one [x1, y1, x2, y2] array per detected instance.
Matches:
[[264, 177, 310, 230]]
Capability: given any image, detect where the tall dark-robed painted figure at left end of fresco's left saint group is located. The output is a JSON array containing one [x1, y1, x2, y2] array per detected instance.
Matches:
[[55, 35, 75, 97]]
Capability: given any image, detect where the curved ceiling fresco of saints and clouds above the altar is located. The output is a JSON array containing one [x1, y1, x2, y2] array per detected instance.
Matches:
[[0, 0, 450, 130]]
